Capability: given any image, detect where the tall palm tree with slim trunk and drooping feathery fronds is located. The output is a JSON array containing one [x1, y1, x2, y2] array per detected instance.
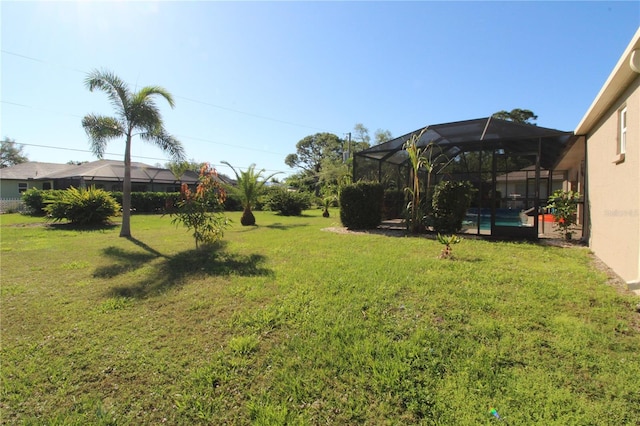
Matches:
[[82, 70, 184, 237]]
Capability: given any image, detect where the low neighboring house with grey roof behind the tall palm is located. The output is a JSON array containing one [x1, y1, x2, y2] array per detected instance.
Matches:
[[0, 160, 198, 200]]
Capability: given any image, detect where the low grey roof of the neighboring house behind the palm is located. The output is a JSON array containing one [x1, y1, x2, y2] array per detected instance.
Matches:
[[0, 160, 198, 184]]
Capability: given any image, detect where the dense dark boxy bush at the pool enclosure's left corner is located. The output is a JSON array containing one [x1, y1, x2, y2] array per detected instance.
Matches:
[[340, 182, 384, 229]]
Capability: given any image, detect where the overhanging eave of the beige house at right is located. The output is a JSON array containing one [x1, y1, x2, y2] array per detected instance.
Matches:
[[575, 27, 640, 135]]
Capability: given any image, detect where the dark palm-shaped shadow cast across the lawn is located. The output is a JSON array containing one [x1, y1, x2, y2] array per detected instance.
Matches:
[[94, 240, 272, 298]]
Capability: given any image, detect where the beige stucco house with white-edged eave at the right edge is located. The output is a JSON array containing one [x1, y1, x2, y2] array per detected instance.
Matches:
[[556, 28, 640, 289]]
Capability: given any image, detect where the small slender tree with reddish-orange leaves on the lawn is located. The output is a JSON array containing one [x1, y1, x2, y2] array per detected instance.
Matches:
[[171, 164, 229, 249]]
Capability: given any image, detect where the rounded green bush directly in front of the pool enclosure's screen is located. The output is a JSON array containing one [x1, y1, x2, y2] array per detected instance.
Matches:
[[431, 181, 475, 233]]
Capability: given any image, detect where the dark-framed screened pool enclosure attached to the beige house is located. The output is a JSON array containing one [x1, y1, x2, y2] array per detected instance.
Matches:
[[353, 117, 576, 238]]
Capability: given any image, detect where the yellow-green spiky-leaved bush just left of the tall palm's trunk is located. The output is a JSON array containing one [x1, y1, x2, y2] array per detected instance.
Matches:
[[45, 187, 120, 225]]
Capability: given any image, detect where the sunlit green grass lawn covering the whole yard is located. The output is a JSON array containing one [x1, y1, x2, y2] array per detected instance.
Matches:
[[0, 210, 640, 425]]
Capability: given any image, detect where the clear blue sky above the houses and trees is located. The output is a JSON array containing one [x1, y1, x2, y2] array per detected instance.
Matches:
[[0, 1, 640, 177]]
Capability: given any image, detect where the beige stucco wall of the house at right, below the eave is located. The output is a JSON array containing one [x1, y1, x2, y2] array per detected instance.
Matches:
[[587, 76, 640, 283]]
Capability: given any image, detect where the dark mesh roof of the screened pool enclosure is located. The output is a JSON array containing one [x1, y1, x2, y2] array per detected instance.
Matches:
[[355, 117, 574, 169]]
